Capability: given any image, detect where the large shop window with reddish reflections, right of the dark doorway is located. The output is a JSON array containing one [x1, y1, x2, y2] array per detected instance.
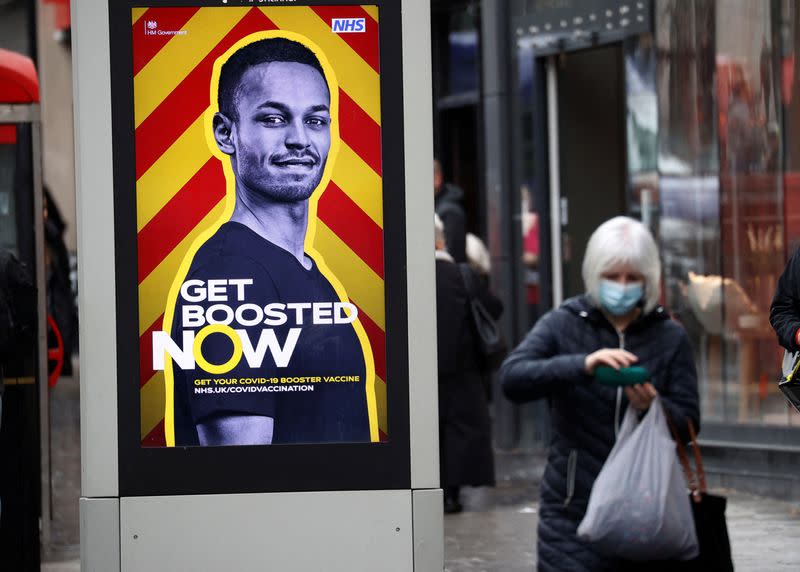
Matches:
[[648, 0, 800, 425]]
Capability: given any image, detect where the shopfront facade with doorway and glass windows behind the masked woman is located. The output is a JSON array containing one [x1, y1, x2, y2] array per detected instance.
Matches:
[[432, 0, 800, 498]]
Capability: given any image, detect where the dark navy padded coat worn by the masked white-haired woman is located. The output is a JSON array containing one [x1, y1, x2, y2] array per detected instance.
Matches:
[[500, 295, 699, 572]]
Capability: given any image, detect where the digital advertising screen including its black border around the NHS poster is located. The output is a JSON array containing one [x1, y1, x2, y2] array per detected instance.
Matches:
[[109, 0, 408, 494]]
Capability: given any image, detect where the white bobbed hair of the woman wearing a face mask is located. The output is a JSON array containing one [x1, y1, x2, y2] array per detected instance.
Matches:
[[583, 216, 661, 313]]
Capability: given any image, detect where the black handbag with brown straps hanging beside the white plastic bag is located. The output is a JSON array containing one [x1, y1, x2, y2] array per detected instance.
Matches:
[[673, 420, 733, 572]]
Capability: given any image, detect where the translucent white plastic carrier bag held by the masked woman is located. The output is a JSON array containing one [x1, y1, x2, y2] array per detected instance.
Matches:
[[578, 397, 698, 561]]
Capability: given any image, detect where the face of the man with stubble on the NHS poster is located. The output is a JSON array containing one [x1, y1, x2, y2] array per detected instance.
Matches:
[[223, 62, 331, 202]]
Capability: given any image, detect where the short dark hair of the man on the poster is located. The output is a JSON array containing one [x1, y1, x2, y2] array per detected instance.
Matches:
[[217, 38, 328, 121]]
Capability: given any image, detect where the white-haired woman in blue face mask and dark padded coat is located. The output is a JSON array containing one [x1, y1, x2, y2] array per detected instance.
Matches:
[[500, 217, 700, 572]]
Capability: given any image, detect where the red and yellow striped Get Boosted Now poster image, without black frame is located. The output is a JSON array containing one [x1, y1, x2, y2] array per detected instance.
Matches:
[[132, 6, 388, 447]]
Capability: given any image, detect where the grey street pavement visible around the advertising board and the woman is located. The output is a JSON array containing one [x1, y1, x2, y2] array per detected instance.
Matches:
[[42, 378, 800, 572]]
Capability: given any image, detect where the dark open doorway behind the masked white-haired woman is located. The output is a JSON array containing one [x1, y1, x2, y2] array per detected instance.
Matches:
[[510, 44, 628, 448]]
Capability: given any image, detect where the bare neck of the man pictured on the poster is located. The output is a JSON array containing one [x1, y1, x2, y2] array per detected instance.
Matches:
[[231, 181, 311, 270]]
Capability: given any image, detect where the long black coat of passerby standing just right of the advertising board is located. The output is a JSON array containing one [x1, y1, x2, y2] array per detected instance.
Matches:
[[436, 253, 499, 487]]
